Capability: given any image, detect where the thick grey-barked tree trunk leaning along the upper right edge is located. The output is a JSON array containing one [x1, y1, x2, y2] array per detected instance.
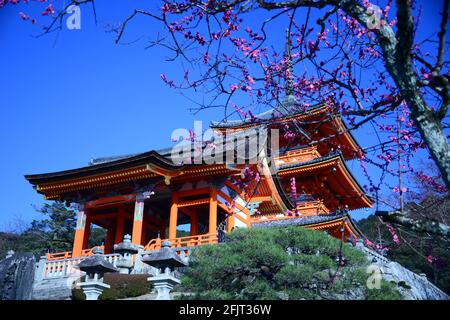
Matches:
[[342, 0, 450, 190]]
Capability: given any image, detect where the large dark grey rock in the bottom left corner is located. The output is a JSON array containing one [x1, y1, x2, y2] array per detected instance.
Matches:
[[0, 253, 35, 300]]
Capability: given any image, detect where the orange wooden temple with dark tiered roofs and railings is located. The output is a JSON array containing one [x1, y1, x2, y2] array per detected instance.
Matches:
[[26, 101, 372, 259]]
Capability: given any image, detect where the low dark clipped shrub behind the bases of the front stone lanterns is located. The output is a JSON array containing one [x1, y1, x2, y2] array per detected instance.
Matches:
[[72, 273, 152, 300]]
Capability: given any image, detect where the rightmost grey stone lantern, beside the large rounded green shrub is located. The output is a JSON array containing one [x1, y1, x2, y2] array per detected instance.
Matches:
[[142, 240, 187, 300]]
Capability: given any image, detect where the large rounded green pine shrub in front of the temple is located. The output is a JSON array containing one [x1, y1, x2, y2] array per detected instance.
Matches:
[[181, 227, 401, 300]]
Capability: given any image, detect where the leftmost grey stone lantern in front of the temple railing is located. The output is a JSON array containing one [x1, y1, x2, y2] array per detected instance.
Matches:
[[78, 247, 118, 300]]
